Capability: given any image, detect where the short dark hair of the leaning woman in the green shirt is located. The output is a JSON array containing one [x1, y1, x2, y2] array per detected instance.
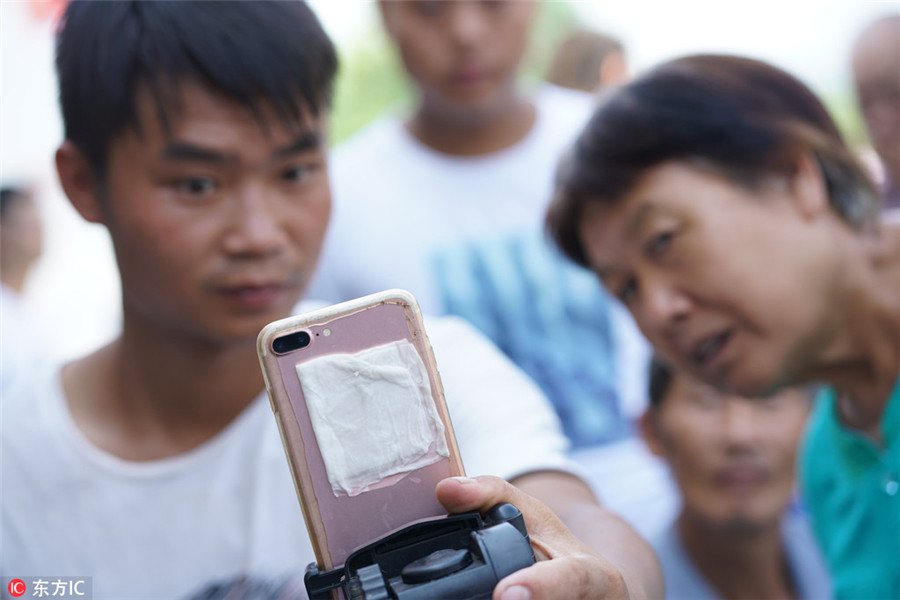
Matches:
[[547, 55, 878, 265]]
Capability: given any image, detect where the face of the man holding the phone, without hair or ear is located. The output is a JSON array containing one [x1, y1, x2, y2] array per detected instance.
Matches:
[[100, 84, 330, 343]]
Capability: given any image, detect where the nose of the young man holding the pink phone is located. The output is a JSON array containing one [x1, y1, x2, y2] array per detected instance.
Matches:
[[223, 186, 283, 257]]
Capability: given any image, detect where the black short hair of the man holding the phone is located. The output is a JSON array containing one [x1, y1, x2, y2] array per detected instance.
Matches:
[[56, 0, 337, 178]]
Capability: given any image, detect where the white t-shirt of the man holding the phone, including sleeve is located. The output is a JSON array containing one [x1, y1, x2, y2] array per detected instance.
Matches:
[[0, 318, 570, 600]]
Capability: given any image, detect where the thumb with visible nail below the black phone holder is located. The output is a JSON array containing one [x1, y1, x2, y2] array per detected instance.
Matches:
[[493, 554, 628, 600]]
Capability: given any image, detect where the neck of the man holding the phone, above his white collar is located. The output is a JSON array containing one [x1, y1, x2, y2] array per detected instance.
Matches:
[[63, 316, 264, 461]]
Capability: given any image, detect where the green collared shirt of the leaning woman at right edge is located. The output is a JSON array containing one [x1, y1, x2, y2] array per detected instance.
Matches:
[[800, 379, 900, 600]]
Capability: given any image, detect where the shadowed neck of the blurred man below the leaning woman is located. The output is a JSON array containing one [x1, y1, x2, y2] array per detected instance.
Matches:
[[677, 512, 797, 600]]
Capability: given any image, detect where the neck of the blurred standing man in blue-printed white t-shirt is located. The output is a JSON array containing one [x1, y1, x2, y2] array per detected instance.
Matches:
[[407, 95, 537, 156]]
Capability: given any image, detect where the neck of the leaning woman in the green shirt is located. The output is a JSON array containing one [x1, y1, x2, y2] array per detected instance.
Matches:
[[808, 220, 900, 441]]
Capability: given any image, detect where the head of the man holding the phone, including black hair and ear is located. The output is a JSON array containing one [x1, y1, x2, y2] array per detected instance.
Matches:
[[57, 1, 337, 343]]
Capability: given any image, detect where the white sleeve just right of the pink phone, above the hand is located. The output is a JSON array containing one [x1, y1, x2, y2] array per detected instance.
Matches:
[[426, 317, 579, 480]]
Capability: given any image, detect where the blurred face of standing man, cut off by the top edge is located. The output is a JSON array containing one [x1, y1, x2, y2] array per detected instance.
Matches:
[[380, 0, 534, 123]]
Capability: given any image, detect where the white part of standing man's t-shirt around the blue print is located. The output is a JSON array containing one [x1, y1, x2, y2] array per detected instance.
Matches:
[[310, 85, 593, 314]]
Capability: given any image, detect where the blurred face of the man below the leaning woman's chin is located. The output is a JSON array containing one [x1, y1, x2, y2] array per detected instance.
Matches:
[[642, 359, 810, 534]]
